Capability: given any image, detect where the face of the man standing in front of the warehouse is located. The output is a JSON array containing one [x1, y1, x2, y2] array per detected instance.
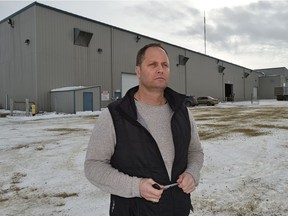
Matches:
[[136, 47, 170, 89]]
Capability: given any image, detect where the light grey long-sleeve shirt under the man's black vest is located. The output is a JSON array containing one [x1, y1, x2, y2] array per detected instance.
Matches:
[[85, 101, 204, 198]]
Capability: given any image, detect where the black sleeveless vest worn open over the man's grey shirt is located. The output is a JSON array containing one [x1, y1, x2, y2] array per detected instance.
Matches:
[[108, 87, 192, 216]]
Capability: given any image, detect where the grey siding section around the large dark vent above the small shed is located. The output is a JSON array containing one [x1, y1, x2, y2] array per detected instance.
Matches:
[[37, 7, 111, 108]]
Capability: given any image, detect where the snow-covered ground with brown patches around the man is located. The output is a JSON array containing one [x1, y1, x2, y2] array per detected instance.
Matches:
[[0, 100, 288, 216]]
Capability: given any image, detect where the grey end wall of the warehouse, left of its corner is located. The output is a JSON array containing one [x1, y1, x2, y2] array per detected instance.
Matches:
[[0, 8, 36, 108]]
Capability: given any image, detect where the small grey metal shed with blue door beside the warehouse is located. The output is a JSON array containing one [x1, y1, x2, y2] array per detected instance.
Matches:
[[50, 86, 101, 114]]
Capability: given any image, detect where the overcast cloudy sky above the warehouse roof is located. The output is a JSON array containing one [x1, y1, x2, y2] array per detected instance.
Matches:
[[0, 0, 288, 69]]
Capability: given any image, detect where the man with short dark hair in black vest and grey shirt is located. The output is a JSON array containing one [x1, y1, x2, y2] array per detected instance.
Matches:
[[85, 43, 203, 216]]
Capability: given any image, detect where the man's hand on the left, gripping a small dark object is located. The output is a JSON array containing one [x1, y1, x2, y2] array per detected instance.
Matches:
[[140, 178, 163, 203]]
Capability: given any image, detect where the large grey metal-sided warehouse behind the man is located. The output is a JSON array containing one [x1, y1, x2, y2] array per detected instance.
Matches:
[[0, 2, 287, 111]]
